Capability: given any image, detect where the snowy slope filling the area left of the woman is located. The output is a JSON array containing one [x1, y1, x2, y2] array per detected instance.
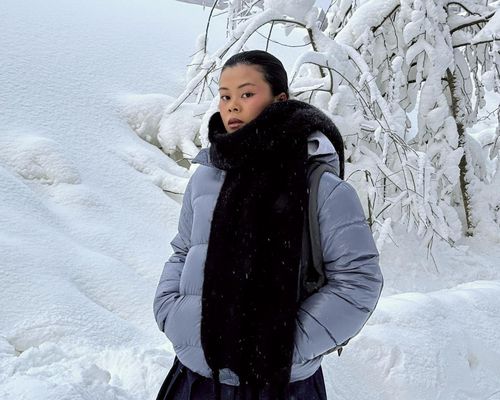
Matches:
[[0, 1, 202, 399]]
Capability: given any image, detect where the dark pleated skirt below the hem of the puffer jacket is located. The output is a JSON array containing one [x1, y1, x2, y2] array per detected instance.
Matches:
[[156, 357, 327, 400]]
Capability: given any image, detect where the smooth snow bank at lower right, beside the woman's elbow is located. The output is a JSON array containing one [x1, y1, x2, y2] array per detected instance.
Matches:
[[326, 280, 500, 400]]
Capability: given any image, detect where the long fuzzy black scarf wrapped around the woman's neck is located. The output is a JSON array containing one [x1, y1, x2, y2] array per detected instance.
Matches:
[[201, 100, 343, 398]]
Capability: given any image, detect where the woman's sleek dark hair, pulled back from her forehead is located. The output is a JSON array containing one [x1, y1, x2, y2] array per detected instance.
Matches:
[[221, 50, 288, 97]]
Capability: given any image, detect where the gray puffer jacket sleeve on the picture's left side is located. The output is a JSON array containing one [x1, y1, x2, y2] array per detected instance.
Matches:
[[153, 178, 193, 336]]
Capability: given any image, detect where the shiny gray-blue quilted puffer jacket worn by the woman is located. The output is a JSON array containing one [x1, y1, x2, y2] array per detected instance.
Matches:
[[153, 131, 383, 385]]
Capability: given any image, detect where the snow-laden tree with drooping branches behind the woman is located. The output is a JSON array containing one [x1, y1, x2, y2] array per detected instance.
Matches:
[[126, 0, 500, 247]]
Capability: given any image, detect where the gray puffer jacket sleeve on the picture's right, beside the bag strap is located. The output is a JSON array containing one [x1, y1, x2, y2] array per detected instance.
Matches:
[[294, 173, 383, 362]]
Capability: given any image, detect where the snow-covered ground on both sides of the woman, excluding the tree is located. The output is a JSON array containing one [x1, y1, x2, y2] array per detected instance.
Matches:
[[0, 0, 500, 400]]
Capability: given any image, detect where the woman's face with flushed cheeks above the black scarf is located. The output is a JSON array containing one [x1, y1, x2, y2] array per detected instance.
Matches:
[[219, 64, 286, 133]]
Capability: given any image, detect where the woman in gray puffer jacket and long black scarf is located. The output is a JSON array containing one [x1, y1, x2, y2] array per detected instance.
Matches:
[[154, 51, 383, 400]]
